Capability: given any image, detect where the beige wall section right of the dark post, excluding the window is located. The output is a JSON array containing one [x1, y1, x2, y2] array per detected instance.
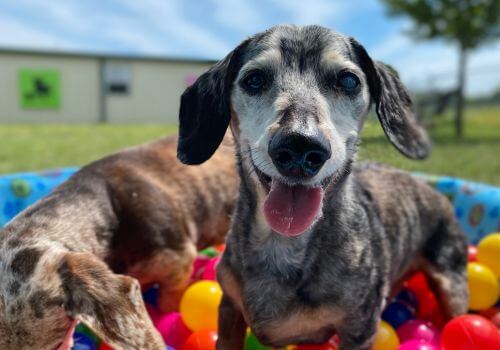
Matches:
[[106, 60, 210, 123]]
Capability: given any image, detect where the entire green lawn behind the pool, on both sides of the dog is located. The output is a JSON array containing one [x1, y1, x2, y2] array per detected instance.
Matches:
[[0, 106, 500, 186]]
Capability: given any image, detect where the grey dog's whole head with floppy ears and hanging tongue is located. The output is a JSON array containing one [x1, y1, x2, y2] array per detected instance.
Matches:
[[178, 26, 429, 235]]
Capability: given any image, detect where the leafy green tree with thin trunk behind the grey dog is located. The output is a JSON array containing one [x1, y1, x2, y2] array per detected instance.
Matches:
[[382, 0, 500, 138]]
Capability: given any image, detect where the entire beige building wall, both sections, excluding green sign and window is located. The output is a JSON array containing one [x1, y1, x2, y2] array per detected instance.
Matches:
[[0, 52, 211, 124]]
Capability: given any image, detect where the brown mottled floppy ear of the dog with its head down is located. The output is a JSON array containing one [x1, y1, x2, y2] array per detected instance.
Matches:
[[58, 253, 165, 350]]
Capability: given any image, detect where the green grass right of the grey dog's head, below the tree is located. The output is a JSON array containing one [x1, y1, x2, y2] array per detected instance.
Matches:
[[360, 106, 500, 186]]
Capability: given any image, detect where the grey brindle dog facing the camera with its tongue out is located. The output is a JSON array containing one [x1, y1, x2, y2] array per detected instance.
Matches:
[[178, 26, 468, 350]]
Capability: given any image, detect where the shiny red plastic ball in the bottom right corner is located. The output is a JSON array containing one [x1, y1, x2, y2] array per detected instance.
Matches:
[[441, 315, 500, 350]]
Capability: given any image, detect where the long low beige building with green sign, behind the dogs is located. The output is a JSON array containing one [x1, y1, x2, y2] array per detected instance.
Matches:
[[0, 49, 214, 123]]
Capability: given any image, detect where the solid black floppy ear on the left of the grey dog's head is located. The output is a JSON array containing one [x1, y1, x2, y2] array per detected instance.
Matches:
[[177, 39, 250, 164]]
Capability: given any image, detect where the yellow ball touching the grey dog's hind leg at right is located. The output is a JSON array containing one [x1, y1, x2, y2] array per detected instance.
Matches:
[[467, 263, 498, 311]]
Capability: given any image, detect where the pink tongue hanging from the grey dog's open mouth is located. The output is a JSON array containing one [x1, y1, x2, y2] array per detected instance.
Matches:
[[264, 181, 323, 236]]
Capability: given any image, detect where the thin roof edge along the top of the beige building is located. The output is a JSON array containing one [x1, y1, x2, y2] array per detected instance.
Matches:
[[0, 47, 217, 64]]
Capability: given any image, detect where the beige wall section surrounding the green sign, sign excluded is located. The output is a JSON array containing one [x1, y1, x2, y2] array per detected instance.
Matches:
[[0, 53, 100, 123]]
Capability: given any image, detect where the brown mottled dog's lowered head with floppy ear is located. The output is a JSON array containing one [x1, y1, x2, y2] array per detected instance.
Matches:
[[0, 247, 164, 350]]
